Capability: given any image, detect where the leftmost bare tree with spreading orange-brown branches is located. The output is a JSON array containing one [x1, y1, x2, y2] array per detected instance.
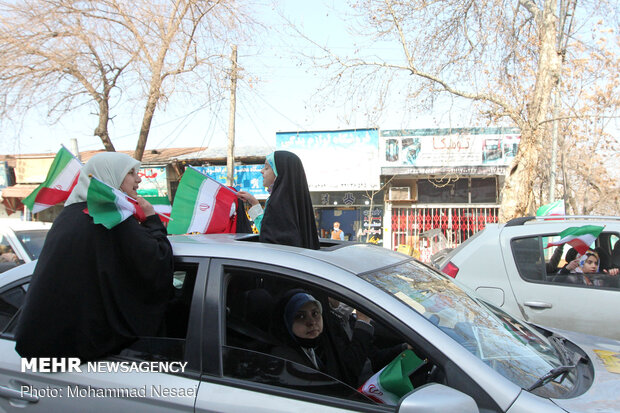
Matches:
[[0, 0, 135, 151]]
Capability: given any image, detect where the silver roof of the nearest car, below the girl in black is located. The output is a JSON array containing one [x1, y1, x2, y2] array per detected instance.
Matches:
[[169, 234, 412, 274]]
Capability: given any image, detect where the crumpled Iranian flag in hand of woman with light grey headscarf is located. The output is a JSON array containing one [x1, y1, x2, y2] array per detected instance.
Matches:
[[86, 176, 146, 229]]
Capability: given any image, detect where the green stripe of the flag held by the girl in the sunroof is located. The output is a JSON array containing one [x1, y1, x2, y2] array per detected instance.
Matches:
[[168, 168, 205, 234]]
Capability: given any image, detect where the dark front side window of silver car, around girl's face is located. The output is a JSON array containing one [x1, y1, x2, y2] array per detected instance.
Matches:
[[221, 267, 439, 403]]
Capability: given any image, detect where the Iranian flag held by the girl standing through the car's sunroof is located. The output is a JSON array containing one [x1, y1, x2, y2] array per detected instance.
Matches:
[[168, 167, 237, 234]]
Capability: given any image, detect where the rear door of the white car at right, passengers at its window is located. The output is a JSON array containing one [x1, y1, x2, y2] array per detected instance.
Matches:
[[500, 227, 620, 339]]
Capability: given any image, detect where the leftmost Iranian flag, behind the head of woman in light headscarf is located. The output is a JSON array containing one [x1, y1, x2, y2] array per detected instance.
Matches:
[[22, 146, 82, 213]]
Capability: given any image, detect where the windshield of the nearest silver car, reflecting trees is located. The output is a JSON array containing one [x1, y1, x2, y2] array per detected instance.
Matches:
[[362, 261, 574, 397]]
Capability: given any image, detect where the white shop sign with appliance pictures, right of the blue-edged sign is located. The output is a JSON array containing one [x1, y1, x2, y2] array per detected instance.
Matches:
[[379, 128, 521, 168]]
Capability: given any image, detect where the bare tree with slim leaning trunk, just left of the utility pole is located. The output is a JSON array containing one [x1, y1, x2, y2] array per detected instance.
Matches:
[[96, 0, 252, 159]]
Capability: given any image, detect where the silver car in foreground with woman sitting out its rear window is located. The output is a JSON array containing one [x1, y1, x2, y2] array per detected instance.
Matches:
[[0, 235, 620, 413]]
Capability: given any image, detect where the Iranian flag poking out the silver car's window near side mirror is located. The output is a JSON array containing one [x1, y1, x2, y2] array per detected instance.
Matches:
[[358, 350, 424, 405]]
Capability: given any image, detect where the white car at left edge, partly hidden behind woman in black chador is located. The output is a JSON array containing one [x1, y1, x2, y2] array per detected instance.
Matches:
[[0, 218, 52, 272]]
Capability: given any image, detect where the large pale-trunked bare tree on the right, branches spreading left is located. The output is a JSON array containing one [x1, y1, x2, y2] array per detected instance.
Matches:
[[298, 0, 615, 220]]
